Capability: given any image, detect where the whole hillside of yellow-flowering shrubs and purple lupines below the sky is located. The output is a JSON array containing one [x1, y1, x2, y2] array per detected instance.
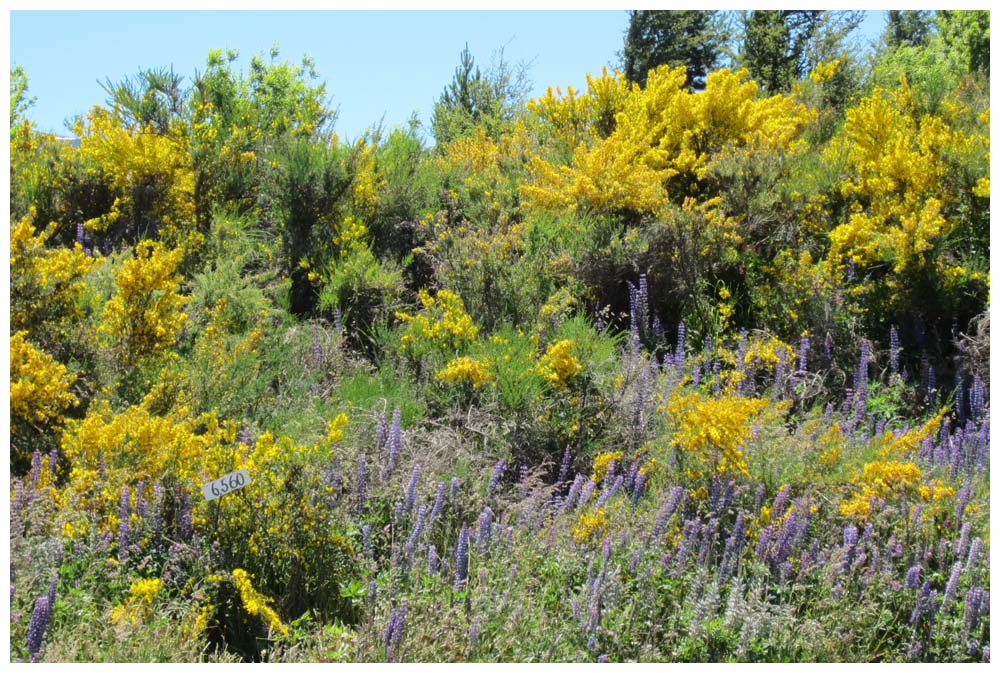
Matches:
[[10, 14, 990, 661]]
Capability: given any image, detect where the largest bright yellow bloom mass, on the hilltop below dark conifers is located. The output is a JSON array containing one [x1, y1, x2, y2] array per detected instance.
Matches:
[[521, 66, 814, 213]]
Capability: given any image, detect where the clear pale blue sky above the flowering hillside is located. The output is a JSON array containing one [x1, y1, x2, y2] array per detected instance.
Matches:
[[10, 10, 884, 138]]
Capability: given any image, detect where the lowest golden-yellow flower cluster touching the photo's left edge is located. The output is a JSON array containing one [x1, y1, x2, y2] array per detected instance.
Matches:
[[10, 331, 77, 424]]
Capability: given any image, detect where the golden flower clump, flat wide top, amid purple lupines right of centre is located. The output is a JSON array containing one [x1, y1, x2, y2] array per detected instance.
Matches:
[[660, 391, 768, 476]]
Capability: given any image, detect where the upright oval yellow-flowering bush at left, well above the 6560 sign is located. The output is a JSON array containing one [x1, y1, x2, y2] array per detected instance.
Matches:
[[98, 241, 187, 369]]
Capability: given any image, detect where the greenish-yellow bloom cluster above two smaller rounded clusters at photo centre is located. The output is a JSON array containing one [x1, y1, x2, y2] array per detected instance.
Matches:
[[396, 290, 479, 355]]
